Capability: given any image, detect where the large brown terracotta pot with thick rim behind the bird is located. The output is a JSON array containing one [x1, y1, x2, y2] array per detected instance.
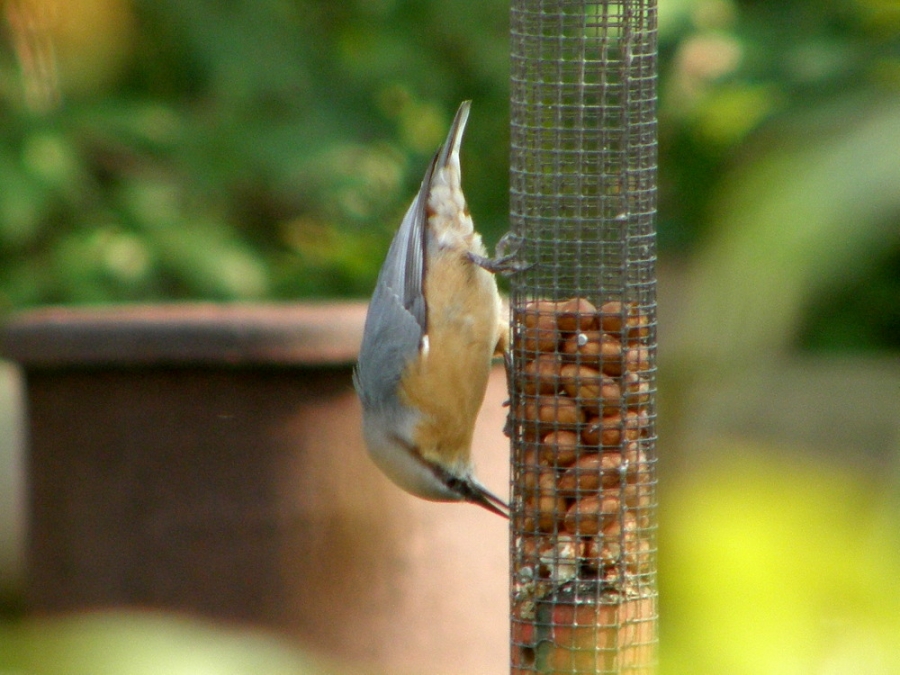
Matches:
[[3, 304, 509, 674]]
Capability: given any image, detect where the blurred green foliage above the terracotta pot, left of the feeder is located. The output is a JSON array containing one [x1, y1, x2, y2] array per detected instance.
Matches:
[[0, 0, 507, 306]]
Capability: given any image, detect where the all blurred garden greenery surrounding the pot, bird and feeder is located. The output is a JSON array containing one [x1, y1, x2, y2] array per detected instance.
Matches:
[[0, 0, 900, 675]]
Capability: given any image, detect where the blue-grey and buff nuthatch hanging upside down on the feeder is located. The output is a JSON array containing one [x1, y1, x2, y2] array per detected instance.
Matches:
[[353, 101, 521, 517]]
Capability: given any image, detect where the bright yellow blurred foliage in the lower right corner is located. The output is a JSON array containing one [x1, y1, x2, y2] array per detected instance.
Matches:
[[660, 438, 900, 675]]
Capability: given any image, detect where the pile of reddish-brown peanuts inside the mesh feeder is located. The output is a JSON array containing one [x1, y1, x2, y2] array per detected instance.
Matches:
[[513, 298, 652, 600]]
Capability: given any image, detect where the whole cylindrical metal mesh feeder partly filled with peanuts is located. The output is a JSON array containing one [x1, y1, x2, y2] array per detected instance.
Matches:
[[509, 0, 657, 675]]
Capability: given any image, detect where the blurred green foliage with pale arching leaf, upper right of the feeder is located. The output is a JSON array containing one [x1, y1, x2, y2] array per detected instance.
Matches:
[[659, 0, 900, 356]]
